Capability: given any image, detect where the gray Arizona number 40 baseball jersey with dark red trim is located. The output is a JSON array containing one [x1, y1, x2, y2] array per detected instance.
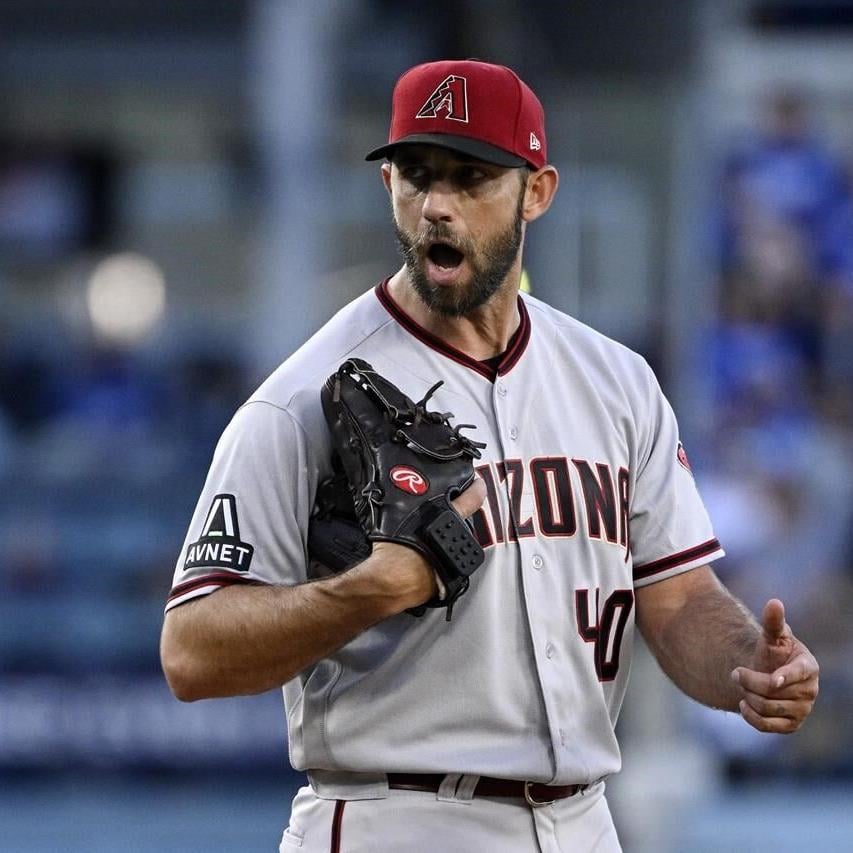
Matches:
[[168, 283, 723, 784]]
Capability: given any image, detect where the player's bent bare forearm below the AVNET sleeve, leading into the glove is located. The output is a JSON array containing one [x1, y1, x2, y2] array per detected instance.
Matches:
[[160, 546, 429, 701]]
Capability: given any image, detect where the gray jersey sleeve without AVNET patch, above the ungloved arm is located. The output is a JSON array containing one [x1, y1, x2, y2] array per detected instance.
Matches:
[[630, 369, 725, 587]]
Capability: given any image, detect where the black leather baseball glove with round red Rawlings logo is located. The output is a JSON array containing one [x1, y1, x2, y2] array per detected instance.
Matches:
[[308, 358, 485, 620]]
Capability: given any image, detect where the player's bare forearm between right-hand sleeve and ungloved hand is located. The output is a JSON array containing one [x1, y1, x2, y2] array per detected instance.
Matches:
[[638, 569, 761, 711]]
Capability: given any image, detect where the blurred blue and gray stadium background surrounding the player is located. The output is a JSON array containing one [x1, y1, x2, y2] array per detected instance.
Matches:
[[0, 0, 853, 853]]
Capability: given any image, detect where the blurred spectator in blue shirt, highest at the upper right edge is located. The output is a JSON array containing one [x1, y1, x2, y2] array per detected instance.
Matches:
[[718, 89, 853, 386]]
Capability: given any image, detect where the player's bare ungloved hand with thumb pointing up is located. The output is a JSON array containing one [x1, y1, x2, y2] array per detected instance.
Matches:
[[732, 598, 819, 734]]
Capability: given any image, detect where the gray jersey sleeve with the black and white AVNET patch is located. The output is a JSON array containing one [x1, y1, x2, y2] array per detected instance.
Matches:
[[166, 401, 316, 610]]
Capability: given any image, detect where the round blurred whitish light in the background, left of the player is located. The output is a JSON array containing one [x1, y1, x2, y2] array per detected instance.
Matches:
[[86, 252, 166, 345]]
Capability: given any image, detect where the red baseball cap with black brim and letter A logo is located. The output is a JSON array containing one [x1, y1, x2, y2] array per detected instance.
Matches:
[[365, 59, 548, 169]]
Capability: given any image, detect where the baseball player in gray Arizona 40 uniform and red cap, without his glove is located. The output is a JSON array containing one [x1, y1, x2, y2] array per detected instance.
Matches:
[[162, 61, 818, 853]]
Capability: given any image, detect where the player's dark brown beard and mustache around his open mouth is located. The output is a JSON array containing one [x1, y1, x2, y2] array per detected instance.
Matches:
[[394, 193, 524, 317]]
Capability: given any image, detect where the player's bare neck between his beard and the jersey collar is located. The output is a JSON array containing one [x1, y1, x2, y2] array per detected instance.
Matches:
[[388, 266, 521, 361]]
